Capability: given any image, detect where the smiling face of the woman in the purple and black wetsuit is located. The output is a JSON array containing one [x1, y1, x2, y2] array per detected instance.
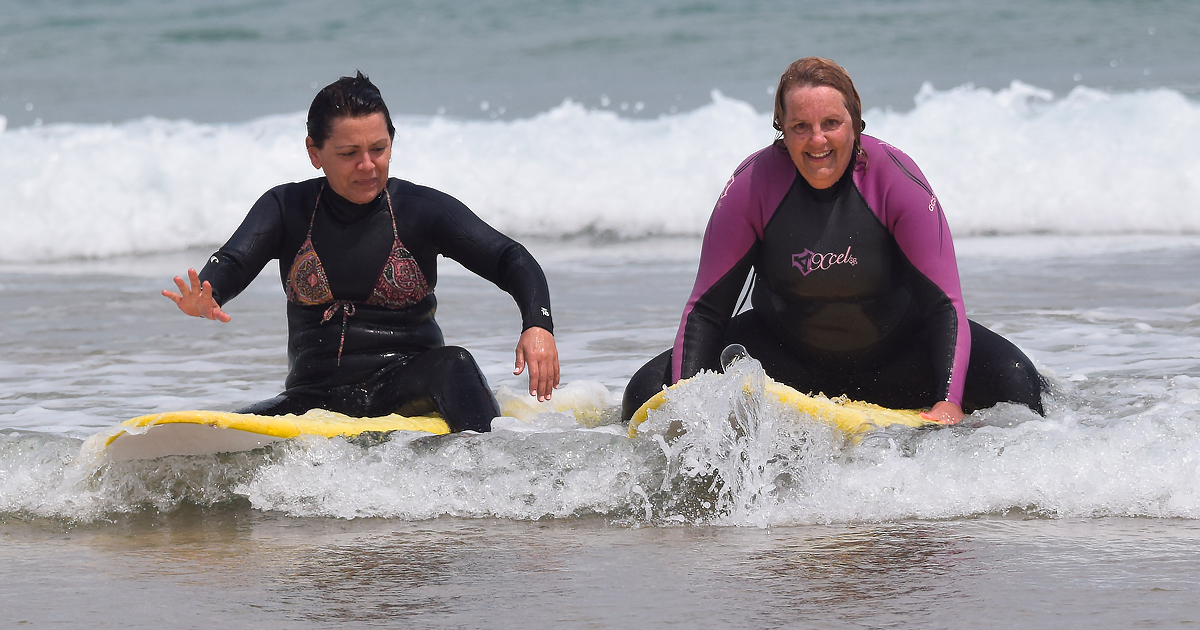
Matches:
[[781, 85, 854, 188]]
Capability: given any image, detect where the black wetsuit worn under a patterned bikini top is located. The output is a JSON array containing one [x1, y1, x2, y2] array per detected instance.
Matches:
[[200, 178, 553, 431]]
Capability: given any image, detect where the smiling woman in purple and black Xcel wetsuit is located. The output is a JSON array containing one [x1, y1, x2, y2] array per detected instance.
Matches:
[[623, 58, 1043, 424]]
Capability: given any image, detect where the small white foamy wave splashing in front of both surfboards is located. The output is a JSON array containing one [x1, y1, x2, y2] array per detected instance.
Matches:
[[0, 372, 1200, 527]]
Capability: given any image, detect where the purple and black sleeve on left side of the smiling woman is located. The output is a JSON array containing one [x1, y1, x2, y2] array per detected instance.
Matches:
[[671, 156, 762, 383]]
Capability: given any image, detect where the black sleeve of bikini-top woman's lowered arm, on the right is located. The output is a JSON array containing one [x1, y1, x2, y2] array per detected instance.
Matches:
[[430, 190, 554, 332]]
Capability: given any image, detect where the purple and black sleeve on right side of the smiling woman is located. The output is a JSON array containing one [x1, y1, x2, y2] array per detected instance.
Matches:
[[856, 136, 971, 407]]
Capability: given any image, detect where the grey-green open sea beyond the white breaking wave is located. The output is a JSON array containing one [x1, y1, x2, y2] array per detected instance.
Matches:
[[0, 0, 1200, 126]]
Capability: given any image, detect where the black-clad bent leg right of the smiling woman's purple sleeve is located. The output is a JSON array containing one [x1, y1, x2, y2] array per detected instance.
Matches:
[[962, 322, 1045, 415]]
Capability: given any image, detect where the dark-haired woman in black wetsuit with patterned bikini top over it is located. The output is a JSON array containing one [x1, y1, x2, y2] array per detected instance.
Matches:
[[163, 73, 559, 431]]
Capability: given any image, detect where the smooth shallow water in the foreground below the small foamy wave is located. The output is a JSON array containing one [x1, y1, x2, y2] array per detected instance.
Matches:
[[0, 513, 1200, 628]]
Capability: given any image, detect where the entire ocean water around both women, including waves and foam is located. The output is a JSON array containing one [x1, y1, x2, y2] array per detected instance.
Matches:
[[0, 0, 1200, 628]]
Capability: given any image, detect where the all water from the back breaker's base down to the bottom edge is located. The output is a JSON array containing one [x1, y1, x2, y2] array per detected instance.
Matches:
[[0, 236, 1200, 628]]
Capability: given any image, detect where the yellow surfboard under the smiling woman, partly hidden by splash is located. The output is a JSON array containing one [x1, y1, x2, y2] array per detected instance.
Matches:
[[629, 378, 942, 438]]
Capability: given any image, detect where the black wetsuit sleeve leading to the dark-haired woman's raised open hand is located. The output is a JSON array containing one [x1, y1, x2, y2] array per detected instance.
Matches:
[[199, 186, 283, 306]]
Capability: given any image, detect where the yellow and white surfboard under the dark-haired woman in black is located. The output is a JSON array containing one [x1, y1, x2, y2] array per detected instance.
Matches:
[[89, 409, 450, 461]]
